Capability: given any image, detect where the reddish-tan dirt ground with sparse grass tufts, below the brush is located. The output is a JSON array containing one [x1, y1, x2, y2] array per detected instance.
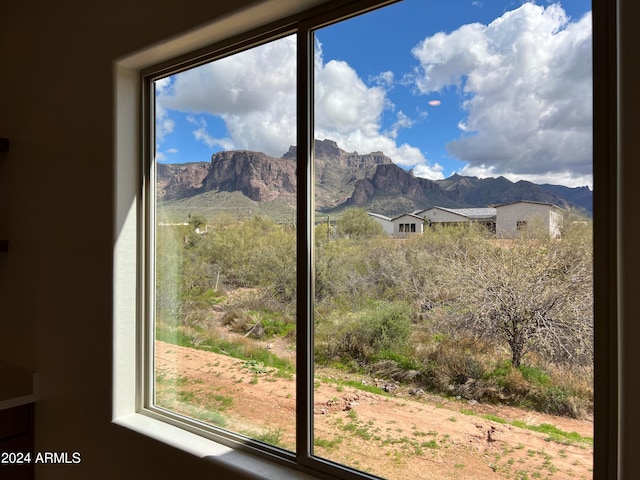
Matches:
[[156, 341, 593, 480]]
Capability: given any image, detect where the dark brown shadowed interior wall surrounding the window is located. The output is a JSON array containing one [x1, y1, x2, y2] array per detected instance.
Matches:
[[0, 0, 640, 480]]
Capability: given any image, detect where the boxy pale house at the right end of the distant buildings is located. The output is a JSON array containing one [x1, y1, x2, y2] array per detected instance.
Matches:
[[496, 201, 564, 238]]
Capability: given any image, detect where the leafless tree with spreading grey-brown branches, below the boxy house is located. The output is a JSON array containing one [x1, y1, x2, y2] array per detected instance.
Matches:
[[447, 227, 593, 367]]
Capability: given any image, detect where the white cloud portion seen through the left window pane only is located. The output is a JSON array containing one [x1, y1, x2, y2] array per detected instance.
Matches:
[[157, 37, 296, 156]]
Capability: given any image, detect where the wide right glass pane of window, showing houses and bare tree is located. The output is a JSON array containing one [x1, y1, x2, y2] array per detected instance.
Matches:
[[314, 0, 593, 479]]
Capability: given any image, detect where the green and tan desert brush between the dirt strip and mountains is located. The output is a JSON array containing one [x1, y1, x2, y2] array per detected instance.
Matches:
[[156, 210, 593, 417]]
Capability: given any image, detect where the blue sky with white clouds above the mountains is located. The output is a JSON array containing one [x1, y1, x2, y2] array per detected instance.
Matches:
[[156, 0, 592, 186]]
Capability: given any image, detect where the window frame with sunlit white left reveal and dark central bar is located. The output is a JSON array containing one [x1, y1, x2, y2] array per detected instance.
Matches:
[[112, 0, 618, 479]]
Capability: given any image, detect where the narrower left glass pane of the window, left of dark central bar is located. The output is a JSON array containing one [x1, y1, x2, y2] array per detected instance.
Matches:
[[154, 37, 296, 450]]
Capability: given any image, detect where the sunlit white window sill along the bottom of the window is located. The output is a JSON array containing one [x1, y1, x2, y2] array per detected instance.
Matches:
[[113, 413, 318, 480]]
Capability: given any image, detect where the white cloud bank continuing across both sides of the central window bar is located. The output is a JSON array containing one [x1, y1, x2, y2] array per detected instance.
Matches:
[[157, 37, 442, 178]]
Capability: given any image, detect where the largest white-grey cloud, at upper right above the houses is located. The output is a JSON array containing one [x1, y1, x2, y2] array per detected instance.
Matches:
[[413, 3, 593, 185]]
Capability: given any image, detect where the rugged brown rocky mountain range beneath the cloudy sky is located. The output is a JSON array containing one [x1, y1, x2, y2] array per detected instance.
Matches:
[[156, 140, 593, 215]]
